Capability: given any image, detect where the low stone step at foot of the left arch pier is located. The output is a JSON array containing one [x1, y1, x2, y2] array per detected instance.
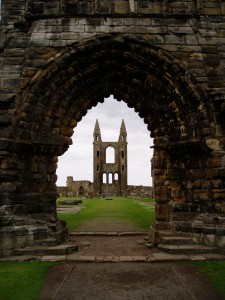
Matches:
[[13, 243, 79, 256]]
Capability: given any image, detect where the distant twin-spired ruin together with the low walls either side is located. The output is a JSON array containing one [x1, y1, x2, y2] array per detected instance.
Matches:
[[57, 120, 152, 197]]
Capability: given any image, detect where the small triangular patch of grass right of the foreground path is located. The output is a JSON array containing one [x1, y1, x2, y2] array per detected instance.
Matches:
[[194, 261, 225, 299]]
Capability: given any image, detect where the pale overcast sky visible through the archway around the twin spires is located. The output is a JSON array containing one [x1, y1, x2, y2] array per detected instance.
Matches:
[[57, 96, 152, 186]]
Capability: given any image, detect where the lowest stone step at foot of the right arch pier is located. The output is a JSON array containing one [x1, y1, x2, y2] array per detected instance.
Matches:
[[158, 244, 217, 254]]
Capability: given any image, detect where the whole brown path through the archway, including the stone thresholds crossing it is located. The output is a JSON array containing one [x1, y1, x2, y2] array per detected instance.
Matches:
[[40, 209, 225, 300]]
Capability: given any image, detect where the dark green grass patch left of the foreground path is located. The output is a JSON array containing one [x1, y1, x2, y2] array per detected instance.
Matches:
[[0, 262, 55, 300]]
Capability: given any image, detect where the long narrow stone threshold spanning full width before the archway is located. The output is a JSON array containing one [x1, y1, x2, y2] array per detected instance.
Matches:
[[0, 252, 225, 263]]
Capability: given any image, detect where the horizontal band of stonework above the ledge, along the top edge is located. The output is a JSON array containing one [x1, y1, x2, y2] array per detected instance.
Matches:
[[2, 0, 225, 19]]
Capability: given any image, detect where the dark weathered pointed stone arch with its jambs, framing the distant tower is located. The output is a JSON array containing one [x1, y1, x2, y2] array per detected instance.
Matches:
[[3, 35, 222, 254]]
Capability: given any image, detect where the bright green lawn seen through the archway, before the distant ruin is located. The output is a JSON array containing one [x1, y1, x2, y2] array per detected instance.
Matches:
[[58, 197, 155, 231]]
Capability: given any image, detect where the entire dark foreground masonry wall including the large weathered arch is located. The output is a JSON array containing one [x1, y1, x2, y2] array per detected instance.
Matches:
[[0, 0, 225, 256]]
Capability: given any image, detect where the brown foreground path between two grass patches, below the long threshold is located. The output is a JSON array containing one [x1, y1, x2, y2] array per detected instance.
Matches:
[[40, 262, 222, 300]]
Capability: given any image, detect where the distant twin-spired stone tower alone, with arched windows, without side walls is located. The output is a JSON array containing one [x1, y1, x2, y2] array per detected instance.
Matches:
[[93, 120, 127, 196]]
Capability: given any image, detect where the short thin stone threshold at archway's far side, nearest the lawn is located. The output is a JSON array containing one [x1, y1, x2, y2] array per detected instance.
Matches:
[[69, 231, 148, 236]]
